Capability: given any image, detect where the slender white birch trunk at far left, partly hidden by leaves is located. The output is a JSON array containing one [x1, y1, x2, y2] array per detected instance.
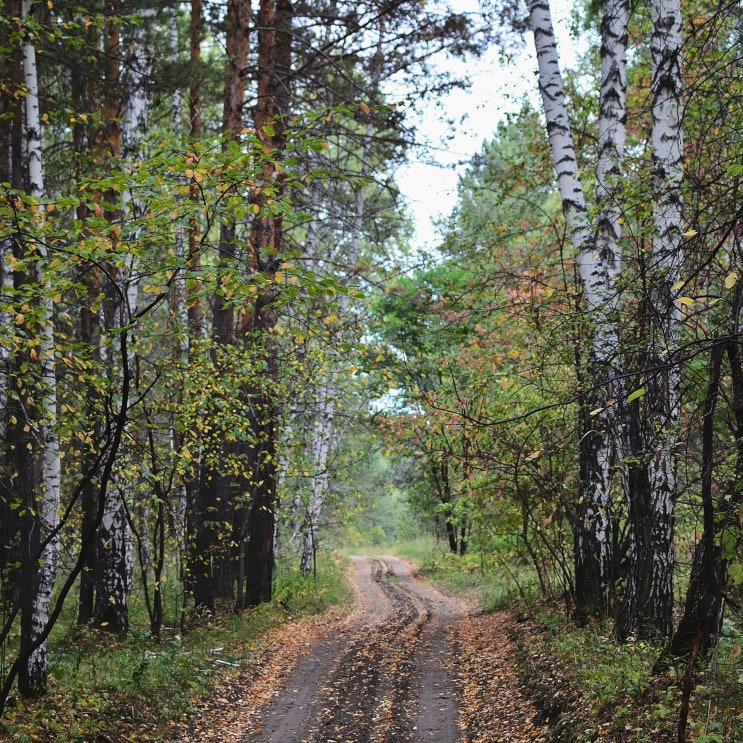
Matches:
[[22, 0, 61, 688]]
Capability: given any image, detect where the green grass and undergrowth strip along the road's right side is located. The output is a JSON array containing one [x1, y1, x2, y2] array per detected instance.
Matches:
[[410, 545, 743, 743]]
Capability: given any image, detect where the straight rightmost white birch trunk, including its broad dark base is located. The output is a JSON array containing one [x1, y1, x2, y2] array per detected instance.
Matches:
[[617, 0, 684, 639]]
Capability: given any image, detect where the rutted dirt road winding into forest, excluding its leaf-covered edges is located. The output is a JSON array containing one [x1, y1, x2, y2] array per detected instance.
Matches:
[[243, 557, 464, 743]]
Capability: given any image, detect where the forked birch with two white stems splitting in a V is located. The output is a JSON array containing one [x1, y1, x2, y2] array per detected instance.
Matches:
[[529, 0, 632, 614]]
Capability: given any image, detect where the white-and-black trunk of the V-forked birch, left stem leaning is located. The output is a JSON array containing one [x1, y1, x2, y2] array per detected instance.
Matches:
[[529, 0, 629, 603]]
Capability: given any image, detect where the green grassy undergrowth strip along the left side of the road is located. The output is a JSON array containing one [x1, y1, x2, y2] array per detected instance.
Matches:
[[0, 554, 350, 743]]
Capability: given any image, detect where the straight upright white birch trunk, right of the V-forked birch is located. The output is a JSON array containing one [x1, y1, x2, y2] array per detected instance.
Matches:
[[645, 0, 684, 637]]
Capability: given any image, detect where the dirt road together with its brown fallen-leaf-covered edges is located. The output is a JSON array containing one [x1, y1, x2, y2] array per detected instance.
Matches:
[[164, 557, 564, 743]]
